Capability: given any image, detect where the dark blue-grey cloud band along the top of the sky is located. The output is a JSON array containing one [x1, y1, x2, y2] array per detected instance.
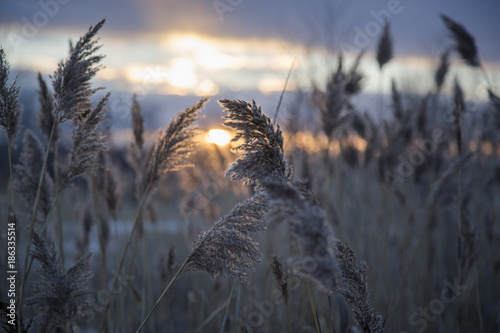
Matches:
[[0, 0, 500, 60]]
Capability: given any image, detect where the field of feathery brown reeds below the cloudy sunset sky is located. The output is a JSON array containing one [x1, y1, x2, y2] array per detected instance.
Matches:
[[0, 16, 500, 333]]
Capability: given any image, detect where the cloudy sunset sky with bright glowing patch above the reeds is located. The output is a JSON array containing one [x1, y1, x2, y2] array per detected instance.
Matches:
[[0, 0, 500, 126]]
